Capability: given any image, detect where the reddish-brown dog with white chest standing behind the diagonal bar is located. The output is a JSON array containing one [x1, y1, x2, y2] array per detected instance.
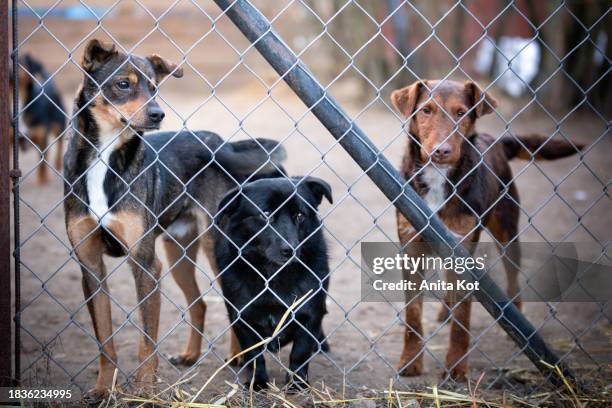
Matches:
[[391, 81, 583, 380]]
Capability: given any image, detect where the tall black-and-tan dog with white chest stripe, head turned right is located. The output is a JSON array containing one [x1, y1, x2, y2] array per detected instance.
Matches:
[[64, 39, 285, 401]]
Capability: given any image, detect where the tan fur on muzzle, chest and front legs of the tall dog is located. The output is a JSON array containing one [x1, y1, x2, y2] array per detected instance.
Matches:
[[65, 40, 184, 401]]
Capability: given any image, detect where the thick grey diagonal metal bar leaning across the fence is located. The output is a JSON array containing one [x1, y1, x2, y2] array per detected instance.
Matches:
[[215, 0, 575, 386]]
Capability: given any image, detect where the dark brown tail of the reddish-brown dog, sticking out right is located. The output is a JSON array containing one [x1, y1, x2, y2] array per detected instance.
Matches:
[[500, 134, 585, 160]]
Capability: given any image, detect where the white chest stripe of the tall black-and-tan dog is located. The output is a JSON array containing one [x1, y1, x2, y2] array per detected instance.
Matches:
[[87, 126, 119, 226]]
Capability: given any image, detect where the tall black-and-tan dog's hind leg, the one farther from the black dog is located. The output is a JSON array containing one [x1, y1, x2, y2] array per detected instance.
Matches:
[[164, 228, 206, 366]]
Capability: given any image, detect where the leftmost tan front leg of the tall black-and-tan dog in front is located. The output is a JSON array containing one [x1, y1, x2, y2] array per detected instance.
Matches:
[[67, 216, 117, 402]]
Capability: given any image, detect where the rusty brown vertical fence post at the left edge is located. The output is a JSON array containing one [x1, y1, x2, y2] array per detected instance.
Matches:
[[0, 3, 13, 387]]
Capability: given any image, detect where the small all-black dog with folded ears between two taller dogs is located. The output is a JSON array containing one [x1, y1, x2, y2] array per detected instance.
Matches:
[[215, 177, 332, 389]]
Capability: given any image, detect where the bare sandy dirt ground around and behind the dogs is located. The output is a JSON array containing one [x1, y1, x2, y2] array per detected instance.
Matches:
[[10, 4, 612, 404]]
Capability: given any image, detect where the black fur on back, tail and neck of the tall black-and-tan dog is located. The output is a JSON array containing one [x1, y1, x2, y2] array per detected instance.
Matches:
[[64, 126, 286, 256]]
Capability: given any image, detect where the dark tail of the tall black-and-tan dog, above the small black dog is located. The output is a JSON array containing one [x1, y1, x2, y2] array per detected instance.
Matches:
[[215, 138, 287, 179]]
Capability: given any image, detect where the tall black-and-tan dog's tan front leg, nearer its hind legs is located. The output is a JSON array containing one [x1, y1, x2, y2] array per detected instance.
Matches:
[[108, 212, 161, 394]]
